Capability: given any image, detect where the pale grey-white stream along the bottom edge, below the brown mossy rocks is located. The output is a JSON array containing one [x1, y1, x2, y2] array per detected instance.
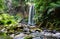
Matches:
[[14, 31, 60, 39]]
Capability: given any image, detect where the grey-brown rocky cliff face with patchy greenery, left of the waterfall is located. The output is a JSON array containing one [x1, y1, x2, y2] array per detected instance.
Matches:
[[6, 0, 29, 18]]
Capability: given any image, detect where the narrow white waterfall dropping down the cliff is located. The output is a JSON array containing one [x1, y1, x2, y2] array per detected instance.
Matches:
[[28, 4, 35, 25]]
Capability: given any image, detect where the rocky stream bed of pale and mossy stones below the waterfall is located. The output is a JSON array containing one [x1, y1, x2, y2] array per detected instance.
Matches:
[[0, 24, 60, 39]]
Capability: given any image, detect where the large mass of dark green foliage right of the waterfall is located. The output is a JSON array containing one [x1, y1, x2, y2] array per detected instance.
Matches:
[[34, 0, 60, 29]]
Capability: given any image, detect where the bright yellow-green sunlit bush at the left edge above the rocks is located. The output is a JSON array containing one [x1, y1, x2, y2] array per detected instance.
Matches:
[[0, 13, 17, 26]]
